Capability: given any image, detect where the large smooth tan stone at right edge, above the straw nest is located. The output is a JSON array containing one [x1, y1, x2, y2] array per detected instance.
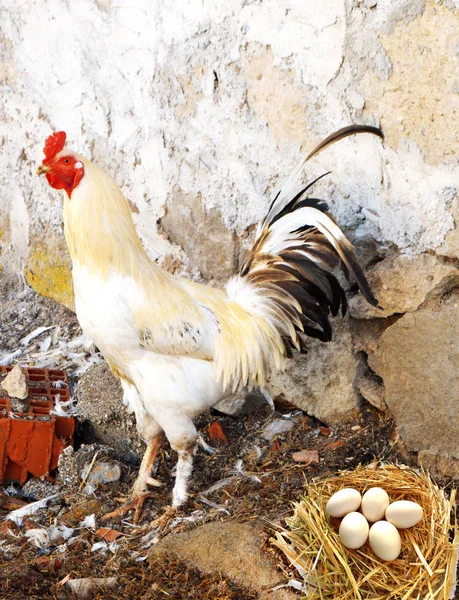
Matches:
[[368, 293, 459, 468]]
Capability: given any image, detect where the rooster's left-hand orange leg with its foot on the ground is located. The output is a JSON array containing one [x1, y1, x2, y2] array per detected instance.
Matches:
[[102, 433, 163, 523]]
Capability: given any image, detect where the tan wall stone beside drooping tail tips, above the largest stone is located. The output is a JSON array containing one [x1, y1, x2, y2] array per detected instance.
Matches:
[[349, 254, 459, 319]]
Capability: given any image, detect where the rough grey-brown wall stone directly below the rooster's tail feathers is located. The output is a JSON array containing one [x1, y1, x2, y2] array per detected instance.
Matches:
[[268, 318, 360, 423]]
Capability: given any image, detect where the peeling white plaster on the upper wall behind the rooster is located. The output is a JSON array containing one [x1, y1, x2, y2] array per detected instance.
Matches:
[[0, 0, 459, 286]]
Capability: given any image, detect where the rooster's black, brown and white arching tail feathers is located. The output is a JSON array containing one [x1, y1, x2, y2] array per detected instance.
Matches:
[[228, 126, 382, 354]]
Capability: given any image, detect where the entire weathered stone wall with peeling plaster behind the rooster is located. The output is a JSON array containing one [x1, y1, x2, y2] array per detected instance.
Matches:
[[0, 0, 459, 470]]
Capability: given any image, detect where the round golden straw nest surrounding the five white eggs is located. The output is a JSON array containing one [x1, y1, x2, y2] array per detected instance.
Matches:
[[272, 464, 459, 600]]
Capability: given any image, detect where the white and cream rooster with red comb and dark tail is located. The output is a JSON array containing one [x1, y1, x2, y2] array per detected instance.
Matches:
[[37, 126, 383, 519]]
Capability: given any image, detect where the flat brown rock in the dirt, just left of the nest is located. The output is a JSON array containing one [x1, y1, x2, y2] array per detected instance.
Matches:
[[151, 522, 294, 600]]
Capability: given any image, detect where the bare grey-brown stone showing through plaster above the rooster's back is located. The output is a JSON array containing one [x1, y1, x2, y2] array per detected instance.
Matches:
[[161, 188, 239, 280]]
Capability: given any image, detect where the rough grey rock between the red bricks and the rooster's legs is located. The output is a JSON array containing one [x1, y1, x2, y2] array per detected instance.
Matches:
[[76, 363, 144, 461]]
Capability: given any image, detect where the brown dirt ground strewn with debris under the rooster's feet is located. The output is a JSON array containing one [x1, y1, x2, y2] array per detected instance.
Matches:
[[0, 396, 415, 600]]
